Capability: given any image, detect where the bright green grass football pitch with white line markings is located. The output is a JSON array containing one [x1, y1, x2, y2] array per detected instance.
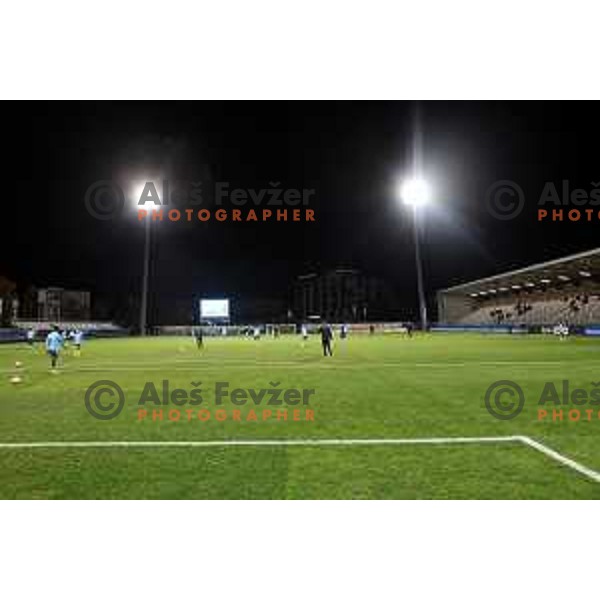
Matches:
[[0, 334, 600, 499]]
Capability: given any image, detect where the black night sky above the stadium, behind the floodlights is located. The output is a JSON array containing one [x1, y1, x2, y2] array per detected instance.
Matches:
[[0, 102, 600, 322]]
